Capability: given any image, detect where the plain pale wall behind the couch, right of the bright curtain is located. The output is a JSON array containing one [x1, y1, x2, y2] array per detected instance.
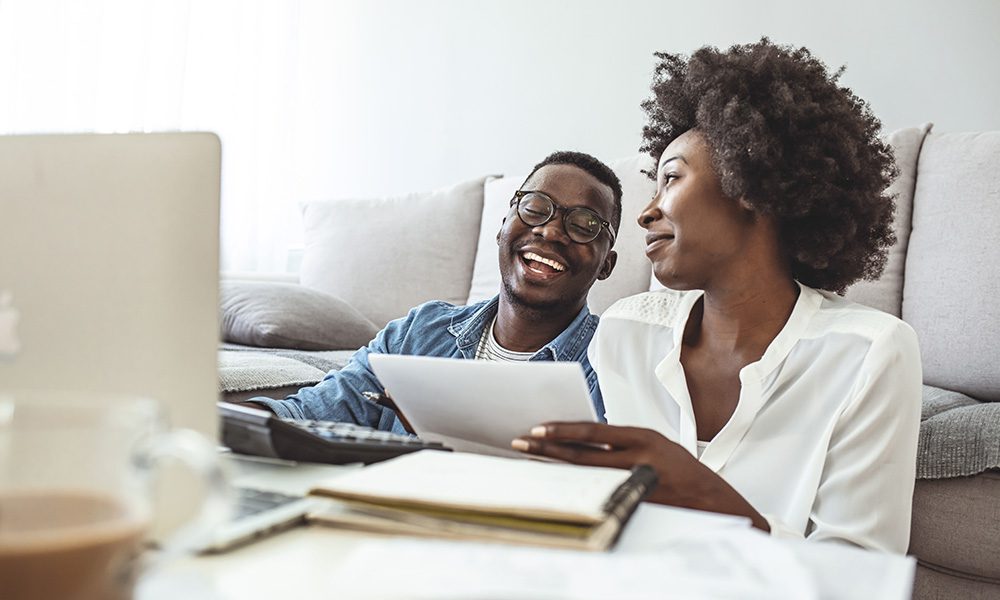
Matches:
[[312, 0, 1000, 195]]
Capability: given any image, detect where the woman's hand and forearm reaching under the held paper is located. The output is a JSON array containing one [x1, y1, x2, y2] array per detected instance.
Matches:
[[511, 423, 770, 531]]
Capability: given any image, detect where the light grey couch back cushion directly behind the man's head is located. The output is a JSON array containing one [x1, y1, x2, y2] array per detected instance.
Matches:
[[468, 154, 656, 314]]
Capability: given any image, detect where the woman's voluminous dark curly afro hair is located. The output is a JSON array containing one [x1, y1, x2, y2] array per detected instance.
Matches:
[[641, 38, 896, 293]]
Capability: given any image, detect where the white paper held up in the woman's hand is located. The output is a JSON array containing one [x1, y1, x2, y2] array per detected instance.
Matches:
[[368, 354, 597, 458]]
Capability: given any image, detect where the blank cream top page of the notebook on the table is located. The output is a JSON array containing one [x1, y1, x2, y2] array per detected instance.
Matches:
[[313, 450, 631, 521]]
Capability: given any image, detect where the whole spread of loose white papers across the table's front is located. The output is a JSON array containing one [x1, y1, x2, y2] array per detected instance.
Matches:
[[329, 515, 914, 600]]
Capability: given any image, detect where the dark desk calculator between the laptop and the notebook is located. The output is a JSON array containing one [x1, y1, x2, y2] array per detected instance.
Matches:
[[223, 402, 451, 465]]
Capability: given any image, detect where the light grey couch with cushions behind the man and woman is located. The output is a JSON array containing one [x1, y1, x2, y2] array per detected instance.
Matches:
[[220, 125, 1000, 599]]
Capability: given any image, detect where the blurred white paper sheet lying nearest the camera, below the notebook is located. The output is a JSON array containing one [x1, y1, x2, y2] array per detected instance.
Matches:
[[331, 529, 820, 600]]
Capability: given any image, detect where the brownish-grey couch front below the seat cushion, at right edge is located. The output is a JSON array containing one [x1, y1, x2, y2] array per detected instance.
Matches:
[[909, 471, 1000, 591]]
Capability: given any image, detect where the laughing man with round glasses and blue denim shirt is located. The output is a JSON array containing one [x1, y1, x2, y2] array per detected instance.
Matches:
[[242, 152, 622, 433]]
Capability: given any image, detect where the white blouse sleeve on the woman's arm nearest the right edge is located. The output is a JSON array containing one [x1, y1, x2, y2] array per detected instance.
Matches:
[[804, 321, 923, 553]]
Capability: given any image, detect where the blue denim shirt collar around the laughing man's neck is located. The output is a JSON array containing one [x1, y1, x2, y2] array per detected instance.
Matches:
[[448, 296, 597, 361]]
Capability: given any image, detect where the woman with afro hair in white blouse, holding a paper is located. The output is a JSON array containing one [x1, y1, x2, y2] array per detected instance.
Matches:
[[512, 38, 921, 552]]
